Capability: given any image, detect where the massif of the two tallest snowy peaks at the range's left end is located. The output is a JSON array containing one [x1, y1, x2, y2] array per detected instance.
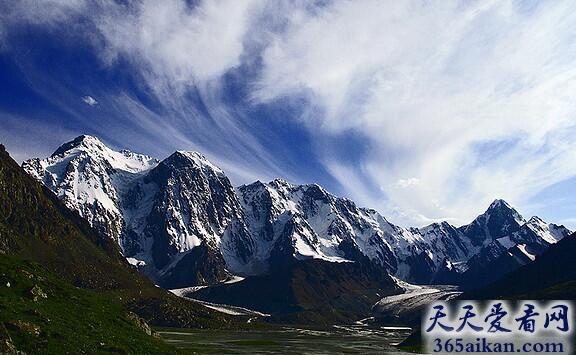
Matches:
[[23, 136, 252, 287]]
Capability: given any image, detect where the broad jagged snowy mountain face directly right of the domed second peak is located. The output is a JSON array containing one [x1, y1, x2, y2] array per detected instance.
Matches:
[[238, 180, 396, 276]]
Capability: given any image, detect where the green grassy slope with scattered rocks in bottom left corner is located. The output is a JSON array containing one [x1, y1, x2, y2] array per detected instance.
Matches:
[[0, 255, 174, 354]]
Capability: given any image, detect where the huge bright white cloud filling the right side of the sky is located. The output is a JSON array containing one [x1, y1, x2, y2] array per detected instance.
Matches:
[[254, 0, 576, 224]]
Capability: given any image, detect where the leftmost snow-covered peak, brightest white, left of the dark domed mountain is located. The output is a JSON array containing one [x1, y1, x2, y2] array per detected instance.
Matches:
[[22, 136, 158, 246]]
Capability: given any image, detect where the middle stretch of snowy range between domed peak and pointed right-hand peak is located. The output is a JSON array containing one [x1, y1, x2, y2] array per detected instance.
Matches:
[[237, 180, 473, 282]]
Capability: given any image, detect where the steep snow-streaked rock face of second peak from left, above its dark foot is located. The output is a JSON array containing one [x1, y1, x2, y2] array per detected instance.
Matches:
[[137, 152, 251, 269]]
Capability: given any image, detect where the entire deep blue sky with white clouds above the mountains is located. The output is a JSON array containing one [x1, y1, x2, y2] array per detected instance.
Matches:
[[0, 0, 576, 229]]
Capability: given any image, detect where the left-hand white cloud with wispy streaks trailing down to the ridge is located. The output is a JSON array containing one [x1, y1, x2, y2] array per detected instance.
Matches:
[[0, 0, 296, 189]]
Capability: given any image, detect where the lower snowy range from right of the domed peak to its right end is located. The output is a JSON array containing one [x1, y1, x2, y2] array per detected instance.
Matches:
[[238, 180, 570, 283]]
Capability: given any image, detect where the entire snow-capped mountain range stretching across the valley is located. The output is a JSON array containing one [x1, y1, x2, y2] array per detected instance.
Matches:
[[23, 136, 570, 287]]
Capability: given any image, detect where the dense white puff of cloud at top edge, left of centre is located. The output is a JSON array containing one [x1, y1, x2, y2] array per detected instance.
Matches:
[[96, 0, 257, 91]]
